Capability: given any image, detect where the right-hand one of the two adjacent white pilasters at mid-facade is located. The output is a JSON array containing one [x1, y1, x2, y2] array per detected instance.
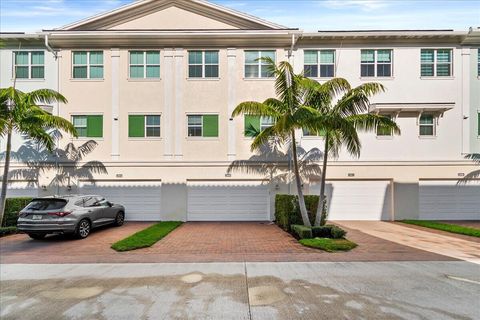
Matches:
[[174, 48, 185, 160]]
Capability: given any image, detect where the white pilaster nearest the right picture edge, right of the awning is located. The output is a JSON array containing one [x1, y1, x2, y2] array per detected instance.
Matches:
[[460, 48, 473, 154]]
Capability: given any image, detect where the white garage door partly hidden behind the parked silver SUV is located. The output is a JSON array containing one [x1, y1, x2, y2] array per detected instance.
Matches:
[[80, 181, 162, 221]]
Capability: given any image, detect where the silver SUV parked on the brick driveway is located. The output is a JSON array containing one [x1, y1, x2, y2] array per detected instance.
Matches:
[[17, 195, 125, 239]]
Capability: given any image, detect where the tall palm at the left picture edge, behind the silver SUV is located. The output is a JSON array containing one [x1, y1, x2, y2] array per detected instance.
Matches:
[[0, 87, 77, 224]]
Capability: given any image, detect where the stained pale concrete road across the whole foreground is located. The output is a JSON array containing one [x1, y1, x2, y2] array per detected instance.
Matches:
[[0, 262, 480, 320]]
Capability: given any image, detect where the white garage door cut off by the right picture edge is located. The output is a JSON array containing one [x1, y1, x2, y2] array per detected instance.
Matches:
[[420, 180, 480, 220]]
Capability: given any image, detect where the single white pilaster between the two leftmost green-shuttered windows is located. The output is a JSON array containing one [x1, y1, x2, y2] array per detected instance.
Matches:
[[110, 49, 120, 161]]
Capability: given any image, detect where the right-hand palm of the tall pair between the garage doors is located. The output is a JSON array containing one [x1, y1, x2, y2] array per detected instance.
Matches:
[[303, 78, 400, 226]]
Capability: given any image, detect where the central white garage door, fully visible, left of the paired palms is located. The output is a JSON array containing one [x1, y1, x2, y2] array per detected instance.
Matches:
[[187, 181, 270, 221]]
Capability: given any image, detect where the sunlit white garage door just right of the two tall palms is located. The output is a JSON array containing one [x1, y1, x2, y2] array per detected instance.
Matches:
[[310, 180, 392, 220]]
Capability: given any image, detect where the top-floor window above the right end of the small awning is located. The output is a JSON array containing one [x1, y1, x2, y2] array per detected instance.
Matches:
[[420, 49, 452, 77]]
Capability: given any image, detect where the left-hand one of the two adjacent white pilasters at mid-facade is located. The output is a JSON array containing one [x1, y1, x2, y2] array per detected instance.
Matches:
[[162, 49, 175, 160]]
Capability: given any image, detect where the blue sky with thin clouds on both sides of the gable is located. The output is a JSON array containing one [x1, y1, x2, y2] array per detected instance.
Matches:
[[0, 0, 480, 32]]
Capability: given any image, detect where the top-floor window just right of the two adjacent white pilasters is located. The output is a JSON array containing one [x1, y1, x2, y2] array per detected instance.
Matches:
[[188, 51, 218, 78]]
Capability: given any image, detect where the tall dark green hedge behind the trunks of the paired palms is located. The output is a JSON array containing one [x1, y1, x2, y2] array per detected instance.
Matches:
[[275, 194, 320, 232]]
